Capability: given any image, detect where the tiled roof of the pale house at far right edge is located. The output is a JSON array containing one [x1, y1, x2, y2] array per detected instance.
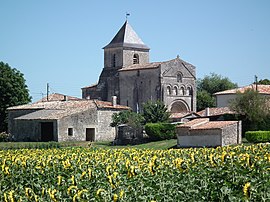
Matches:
[[214, 84, 270, 95]]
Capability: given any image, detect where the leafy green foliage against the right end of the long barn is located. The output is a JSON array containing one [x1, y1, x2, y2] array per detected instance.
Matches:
[[110, 110, 144, 128]]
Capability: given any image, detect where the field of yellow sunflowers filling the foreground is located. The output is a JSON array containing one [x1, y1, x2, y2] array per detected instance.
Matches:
[[0, 144, 270, 202]]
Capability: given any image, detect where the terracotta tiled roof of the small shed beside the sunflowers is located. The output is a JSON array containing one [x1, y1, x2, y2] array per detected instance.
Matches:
[[177, 118, 237, 130]]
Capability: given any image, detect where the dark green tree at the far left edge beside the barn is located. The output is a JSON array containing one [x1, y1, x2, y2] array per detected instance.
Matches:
[[0, 62, 31, 132]]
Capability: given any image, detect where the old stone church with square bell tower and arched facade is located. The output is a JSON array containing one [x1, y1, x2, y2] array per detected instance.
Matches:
[[82, 21, 196, 113]]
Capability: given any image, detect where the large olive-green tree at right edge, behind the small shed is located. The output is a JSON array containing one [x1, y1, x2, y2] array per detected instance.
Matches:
[[230, 89, 270, 131]]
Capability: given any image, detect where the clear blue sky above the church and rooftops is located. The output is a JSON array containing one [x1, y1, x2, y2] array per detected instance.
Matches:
[[0, 0, 270, 101]]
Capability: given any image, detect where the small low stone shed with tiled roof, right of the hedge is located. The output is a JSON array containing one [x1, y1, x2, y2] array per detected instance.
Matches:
[[176, 118, 242, 147]]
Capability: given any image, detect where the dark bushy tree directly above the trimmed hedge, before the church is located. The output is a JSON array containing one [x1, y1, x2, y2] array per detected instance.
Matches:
[[143, 100, 170, 123]]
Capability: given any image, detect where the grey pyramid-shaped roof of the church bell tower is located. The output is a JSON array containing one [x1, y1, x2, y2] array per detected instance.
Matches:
[[104, 20, 150, 50]]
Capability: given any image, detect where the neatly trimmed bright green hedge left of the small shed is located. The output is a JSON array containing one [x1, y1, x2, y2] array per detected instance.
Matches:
[[145, 123, 176, 140]]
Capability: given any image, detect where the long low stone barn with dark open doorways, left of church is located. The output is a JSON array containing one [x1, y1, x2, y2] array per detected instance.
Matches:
[[8, 94, 129, 142]]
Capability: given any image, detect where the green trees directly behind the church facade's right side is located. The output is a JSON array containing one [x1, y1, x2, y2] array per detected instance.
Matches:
[[197, 73, 237, 111]]
